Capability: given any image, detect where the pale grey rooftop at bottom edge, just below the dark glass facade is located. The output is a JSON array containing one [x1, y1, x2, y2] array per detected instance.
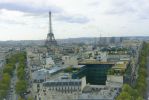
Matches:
[[79, 85, 118, 100]]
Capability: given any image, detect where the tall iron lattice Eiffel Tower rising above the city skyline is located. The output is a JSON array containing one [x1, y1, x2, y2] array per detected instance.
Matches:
[[45, 12, 57, 47]]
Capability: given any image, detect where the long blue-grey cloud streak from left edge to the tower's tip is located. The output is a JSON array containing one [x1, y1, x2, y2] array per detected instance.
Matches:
[[0, 2, 62, 14]]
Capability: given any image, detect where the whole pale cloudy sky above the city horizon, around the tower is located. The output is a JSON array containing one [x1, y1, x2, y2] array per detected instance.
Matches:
[[0, 0, 149, 40]]
